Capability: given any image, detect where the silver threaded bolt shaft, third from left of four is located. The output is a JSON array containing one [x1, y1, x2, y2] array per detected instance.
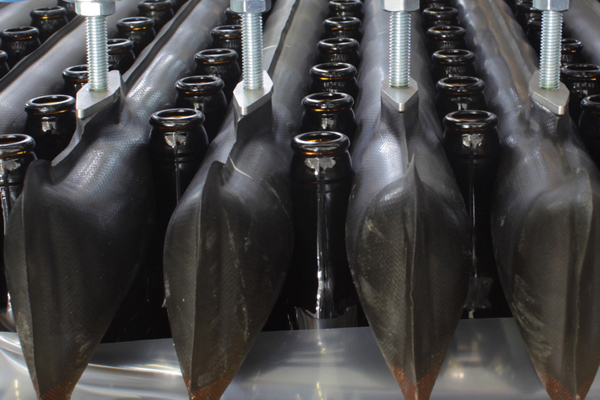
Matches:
[[390, 11, 411, 87]]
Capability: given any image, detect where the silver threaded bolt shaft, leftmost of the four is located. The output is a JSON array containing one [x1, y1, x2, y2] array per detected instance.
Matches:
[[86, 16, 108, 91]]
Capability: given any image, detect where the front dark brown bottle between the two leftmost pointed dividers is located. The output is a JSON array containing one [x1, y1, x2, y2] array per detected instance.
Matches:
[[149, 108, 208, 222]]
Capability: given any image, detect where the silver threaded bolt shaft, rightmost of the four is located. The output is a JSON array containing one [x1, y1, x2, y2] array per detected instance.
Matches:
[[540, 11, 562, 90]]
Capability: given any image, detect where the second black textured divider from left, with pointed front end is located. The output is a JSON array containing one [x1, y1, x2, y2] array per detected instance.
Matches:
[[164, 0, 327, 399]]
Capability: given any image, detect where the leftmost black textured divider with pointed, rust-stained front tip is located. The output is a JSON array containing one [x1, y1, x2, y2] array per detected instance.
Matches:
[[5, 0, 227, 399]]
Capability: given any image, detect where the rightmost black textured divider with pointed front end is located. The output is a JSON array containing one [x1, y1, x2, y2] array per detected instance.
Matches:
[[458, 0, 600, 400]]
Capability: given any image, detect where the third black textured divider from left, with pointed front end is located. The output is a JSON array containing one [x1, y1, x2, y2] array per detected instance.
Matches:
[[346, 2, 469, 400]]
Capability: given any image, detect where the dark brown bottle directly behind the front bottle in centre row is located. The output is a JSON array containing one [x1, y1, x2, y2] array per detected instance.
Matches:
[[301, 92, 356, 141]]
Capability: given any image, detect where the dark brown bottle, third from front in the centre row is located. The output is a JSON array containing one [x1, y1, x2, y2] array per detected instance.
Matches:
[[310, 63, 358, 99]]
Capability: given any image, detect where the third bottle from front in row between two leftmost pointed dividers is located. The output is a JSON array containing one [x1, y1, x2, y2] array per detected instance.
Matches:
[[194, 49, 242, 103]]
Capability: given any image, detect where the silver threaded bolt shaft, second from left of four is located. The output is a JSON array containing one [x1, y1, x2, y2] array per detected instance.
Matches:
[[242, 13, 263, 90]]
